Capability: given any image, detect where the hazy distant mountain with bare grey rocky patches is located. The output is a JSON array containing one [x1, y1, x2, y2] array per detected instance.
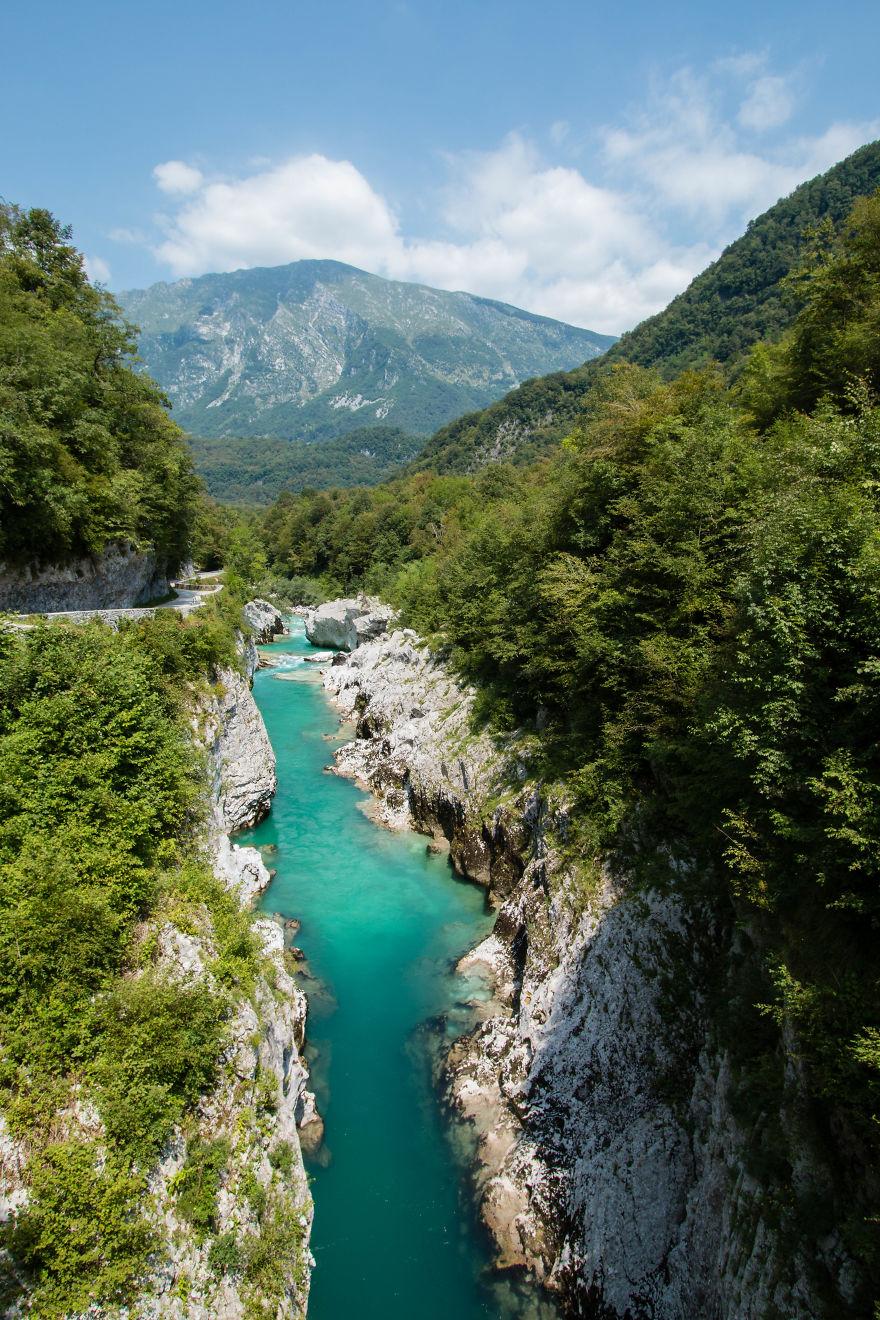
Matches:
[[119, 261, 613, 444]]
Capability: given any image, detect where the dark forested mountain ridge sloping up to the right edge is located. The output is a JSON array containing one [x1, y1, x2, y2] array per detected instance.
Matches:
[[413, 143, 880, 473]]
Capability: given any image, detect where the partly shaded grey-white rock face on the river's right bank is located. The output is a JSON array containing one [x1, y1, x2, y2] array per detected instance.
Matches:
[[325, 612, 858, 1320]]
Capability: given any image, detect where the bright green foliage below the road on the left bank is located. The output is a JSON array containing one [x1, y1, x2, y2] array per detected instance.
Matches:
[[0, 593, 269, 1316]]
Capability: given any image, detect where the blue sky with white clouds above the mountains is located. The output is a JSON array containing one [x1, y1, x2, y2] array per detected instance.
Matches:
[[0, 0, 880, 334]]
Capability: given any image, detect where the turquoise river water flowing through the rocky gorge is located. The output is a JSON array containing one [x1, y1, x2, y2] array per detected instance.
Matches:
[[240, 620, 556, 1320]]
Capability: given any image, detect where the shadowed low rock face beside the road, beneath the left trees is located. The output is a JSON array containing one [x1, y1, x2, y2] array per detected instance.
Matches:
[[0, 543, 169, 614]]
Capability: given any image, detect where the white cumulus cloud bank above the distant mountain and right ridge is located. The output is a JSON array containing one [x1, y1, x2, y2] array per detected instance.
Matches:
[[143, 54, 880, 333]]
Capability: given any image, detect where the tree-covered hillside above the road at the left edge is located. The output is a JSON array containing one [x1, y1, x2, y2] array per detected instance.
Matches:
[[0, 206, 199, 570]]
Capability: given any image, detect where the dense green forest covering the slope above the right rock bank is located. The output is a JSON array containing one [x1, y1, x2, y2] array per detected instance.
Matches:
[[250, 193, 880, 1284]]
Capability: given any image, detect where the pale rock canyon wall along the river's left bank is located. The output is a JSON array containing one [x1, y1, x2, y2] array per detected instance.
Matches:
[[0, 617, 321, 1320]]
